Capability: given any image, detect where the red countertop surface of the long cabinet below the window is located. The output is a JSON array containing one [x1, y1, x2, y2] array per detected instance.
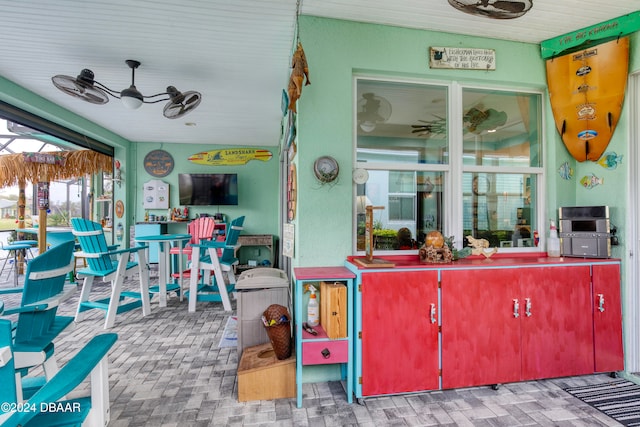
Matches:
[[347, 252, 620, 270]]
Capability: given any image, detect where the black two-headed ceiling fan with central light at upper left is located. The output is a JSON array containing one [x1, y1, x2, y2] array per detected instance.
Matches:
[[51, 59, 202, 119]]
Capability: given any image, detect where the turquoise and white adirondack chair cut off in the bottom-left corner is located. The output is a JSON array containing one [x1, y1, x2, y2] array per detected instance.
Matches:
[[0, 319, 118, 427]]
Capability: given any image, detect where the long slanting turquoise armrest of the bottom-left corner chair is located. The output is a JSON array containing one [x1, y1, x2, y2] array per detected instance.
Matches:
[[7, 333, 118, 425]]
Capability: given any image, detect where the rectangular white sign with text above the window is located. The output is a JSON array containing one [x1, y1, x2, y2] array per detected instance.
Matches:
[[429, 47, 496, 71]]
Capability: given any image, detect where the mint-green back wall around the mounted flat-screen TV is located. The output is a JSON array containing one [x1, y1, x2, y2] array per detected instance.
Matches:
[[128, 142, 279, 235]]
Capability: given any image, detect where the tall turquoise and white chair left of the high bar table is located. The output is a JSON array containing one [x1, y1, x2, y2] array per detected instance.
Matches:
[[71, 218, 151, 329]]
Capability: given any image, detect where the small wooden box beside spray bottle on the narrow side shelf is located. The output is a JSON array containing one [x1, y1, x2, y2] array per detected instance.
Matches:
[[320, 282, 347, 339]]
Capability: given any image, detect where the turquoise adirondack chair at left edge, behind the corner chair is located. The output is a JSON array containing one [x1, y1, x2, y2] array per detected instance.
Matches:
[[0, 242, 77, 398]]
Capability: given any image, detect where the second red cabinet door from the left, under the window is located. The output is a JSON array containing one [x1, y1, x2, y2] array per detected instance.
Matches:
[[441, 269, 522, 388]]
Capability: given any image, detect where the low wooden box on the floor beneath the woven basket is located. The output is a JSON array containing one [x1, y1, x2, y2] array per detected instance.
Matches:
[[238, 344, 296, 402]]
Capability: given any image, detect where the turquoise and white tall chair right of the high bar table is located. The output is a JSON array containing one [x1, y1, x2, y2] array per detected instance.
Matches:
[[188, 216, 244, 313]]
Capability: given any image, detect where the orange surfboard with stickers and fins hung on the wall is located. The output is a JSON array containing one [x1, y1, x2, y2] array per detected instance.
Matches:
[[547, 37, 629, 162]]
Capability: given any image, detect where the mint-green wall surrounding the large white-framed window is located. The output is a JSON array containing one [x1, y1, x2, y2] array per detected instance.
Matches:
[[293, 16, 640, 381]]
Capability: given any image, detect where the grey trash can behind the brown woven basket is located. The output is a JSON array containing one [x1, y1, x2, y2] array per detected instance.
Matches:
[[235, 268, 291, 361]]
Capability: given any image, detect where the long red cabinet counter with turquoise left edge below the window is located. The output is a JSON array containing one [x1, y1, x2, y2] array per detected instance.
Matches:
[[344, 252, 624, 399]]
